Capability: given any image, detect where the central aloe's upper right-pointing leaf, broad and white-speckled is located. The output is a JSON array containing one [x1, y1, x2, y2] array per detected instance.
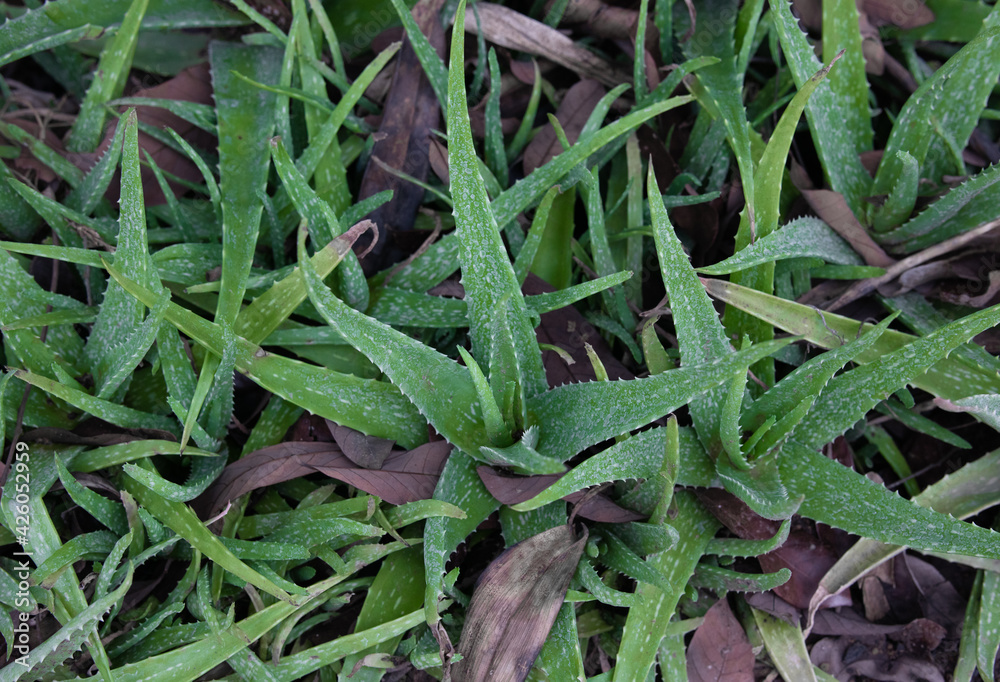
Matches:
[[528, 341, 787, 460]]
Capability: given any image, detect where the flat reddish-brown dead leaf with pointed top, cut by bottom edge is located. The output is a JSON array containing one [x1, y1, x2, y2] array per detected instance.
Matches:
[[687, 599, 754, 682]]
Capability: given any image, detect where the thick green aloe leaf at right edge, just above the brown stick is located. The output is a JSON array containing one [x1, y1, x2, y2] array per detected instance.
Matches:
[[877, 166, 1000, 253]]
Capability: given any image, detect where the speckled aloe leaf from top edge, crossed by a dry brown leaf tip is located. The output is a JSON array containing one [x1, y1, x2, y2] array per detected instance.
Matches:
[[768, 0, 871, 216]]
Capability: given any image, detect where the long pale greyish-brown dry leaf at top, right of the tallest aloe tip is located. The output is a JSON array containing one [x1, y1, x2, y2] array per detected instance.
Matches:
[[465, 2, 632, 87]]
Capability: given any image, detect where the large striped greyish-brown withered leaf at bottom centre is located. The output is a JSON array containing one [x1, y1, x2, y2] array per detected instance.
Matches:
[[452, 525, 587, 682]]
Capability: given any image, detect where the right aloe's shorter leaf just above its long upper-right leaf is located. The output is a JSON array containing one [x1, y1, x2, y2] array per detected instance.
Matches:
[[741, 317, 895, 428]]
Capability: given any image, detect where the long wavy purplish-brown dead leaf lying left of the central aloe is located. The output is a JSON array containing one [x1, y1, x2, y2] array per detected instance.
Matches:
[[196, 441, 451, 516]]
